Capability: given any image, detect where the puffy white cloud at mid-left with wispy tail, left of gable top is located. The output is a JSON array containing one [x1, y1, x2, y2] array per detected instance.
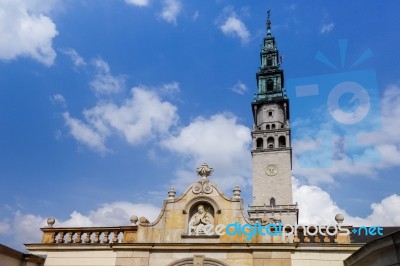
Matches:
[[64, 87, 178, 153]]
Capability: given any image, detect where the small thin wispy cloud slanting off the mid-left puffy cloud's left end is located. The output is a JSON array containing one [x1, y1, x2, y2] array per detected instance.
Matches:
[[63, 112, 107, 154]]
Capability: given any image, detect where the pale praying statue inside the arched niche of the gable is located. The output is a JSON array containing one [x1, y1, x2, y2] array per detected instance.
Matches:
[[189, 204, 214, 235]]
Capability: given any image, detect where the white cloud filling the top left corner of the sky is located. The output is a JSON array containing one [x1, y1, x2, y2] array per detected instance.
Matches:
[[0, 0, 58, 66]]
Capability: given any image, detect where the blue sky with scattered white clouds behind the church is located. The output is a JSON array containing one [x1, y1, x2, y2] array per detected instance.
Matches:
[[0, 0, 400, 250]]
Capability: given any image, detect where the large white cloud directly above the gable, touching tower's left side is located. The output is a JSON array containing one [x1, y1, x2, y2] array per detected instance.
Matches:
[[161, 114, 251, 190]]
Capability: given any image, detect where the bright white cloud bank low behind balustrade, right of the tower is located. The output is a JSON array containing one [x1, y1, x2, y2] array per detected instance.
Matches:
[[293, 179, 400, 226]]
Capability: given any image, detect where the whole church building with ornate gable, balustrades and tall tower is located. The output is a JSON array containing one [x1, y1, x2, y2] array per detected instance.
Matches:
[[26, 13, 363, 266]]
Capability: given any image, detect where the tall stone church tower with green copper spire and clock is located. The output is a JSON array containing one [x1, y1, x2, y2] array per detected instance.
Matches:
[[248, 11, 298, 224]]
